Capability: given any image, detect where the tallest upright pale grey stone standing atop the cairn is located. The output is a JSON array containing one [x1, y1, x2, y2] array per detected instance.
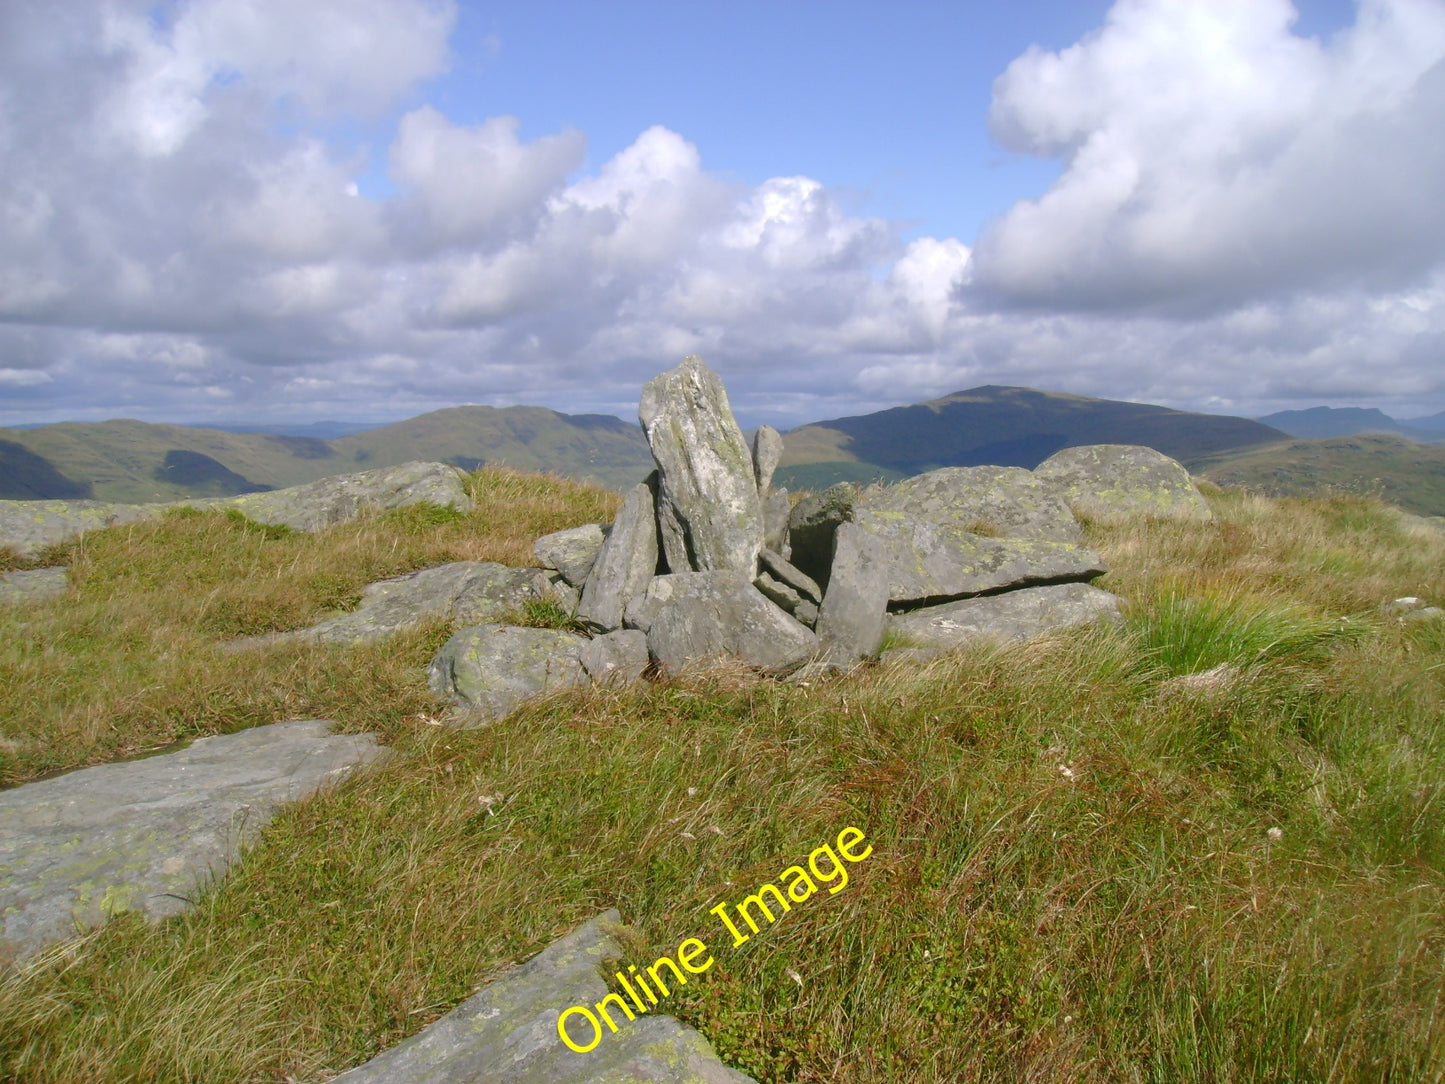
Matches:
[[637, 356, 763, 575]]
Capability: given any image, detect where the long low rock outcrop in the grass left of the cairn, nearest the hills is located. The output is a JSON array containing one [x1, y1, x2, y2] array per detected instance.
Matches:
[[192, 463, 471, 530]]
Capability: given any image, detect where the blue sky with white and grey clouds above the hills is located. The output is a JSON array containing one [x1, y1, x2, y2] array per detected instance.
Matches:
[[0, 0, 1445, 429]]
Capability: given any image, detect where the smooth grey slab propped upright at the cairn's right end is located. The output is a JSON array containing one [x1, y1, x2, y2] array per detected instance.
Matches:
[[815, 523, 893, 666]]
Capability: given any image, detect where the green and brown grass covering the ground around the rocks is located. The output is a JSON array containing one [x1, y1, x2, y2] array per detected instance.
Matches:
[[0, 471, 1445, 1083]]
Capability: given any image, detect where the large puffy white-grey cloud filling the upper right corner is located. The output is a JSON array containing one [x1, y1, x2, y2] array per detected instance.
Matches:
[[975, 0, 1445, 311]]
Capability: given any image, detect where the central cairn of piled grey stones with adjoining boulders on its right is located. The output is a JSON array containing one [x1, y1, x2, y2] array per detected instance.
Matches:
[[431, 357, 1208, 717]]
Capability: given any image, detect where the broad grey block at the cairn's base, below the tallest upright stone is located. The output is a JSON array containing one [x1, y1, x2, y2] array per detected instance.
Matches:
[[627, 571, 818, 674]]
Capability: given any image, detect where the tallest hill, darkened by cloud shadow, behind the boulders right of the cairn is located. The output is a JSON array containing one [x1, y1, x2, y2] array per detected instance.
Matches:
[[783, 386, 1283, 474]]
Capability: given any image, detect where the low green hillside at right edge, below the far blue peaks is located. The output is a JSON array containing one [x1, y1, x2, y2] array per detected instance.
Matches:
[[1186, 434, 1445, 516]]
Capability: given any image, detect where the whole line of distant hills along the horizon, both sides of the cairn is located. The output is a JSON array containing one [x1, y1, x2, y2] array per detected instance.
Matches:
[[0, 386, 1445, 515]]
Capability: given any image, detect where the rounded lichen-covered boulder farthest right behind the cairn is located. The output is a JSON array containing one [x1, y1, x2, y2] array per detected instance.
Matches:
[[1033, 444, 1214, 520]]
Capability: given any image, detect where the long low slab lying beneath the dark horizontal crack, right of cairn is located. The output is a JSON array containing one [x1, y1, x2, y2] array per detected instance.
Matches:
[[889, 584, 1118, 648]]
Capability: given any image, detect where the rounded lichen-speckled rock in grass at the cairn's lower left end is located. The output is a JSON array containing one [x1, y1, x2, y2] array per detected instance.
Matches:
[[426, 624, 588, 720]]
